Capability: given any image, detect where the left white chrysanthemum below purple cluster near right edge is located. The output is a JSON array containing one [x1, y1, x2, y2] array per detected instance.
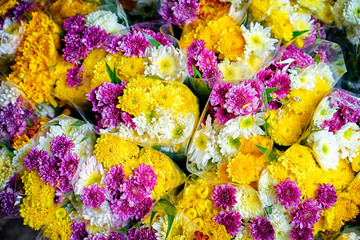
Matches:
[[312, 129, 340, 170]]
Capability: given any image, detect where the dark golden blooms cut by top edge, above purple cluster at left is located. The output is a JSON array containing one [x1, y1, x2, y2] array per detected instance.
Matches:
[[50, 0, 100, 26]]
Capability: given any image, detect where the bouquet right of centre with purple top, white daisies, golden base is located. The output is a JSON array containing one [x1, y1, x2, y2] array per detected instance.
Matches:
[[187, 80, 272, 184]]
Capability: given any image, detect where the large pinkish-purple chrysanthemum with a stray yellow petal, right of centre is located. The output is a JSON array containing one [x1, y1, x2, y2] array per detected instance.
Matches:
[[224, 80, 261, 116]]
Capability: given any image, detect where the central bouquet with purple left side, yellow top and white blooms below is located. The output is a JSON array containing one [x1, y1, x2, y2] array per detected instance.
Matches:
[[88, 76, 199, 152]]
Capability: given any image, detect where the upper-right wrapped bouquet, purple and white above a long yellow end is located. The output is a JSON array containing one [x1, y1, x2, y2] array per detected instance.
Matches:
[[257, 42, 345, 146]]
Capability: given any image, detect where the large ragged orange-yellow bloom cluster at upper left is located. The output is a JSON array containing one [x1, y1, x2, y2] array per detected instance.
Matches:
[[7, 12, 61, 106]]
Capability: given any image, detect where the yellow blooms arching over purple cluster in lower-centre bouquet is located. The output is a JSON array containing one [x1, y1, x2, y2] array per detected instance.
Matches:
[[94, 134, 183, 200]]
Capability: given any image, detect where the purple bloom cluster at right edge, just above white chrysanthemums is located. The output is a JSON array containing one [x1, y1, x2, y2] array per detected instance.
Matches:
[[321, 89, 360, 133]]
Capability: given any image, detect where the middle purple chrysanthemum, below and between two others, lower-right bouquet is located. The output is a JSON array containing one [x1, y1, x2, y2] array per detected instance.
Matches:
[[289, 199, 321, 228]]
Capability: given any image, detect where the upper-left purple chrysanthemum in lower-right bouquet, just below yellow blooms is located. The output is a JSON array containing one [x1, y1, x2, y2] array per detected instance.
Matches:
[[274, 178, 302, 209]]
